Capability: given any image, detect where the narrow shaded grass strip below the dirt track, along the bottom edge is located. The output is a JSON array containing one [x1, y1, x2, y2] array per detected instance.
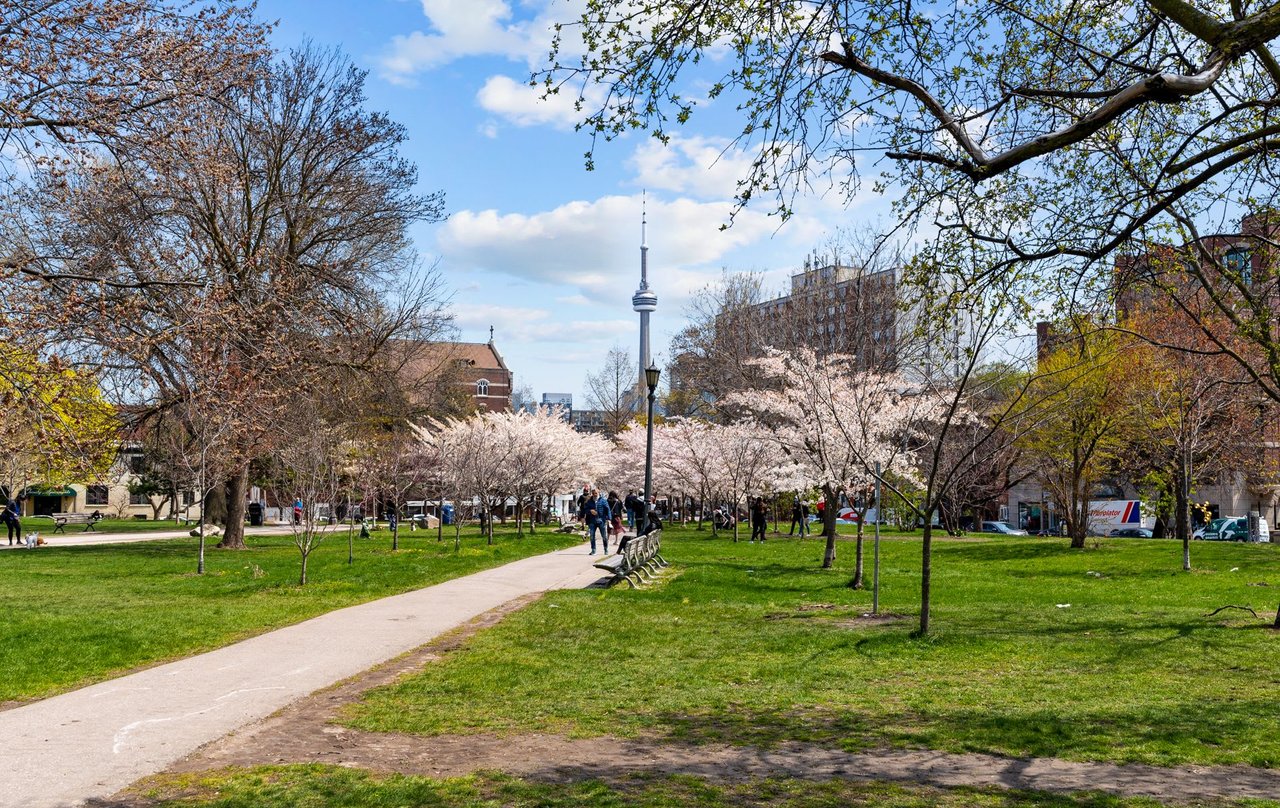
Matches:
[[124, 766, 1280, 808]]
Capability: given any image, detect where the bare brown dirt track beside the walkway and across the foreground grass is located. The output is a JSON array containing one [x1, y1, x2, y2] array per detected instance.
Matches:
[[145, 595, 1280, 805]]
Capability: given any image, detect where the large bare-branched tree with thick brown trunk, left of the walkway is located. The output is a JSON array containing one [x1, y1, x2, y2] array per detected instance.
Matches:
[[31, 46, 444, 547]]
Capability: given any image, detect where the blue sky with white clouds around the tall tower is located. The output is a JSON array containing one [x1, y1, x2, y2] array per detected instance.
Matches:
[[259, 0, 887, 407]]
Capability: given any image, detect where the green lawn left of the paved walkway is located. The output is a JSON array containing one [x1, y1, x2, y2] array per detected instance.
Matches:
[[0, 528, 579, 702]]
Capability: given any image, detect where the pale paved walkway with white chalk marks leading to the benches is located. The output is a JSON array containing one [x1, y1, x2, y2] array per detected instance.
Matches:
[[0, 545, 600, 808]]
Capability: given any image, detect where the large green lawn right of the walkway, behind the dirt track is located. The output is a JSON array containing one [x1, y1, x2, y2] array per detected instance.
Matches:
[[346, 530, 1280, 767]]
